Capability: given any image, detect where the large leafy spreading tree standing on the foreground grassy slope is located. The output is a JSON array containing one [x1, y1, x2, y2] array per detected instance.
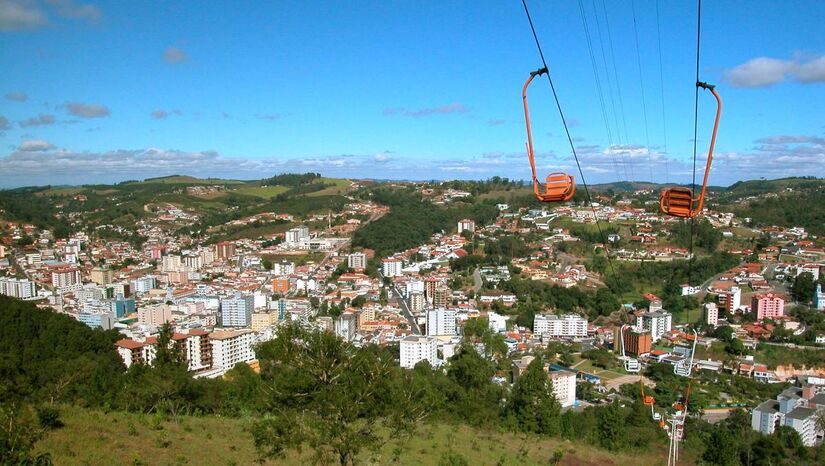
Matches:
[[252, 323, 427, 466]]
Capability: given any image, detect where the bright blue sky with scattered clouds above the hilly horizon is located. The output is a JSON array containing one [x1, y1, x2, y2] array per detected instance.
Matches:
[[0, 0, 825, 187]]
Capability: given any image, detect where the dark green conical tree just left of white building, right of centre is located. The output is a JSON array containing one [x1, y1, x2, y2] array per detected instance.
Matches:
[[506, 356, 561, 435]]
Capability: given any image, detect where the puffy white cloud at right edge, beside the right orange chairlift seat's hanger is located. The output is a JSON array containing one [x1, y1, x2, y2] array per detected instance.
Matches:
[[724, 55, 825, 87]]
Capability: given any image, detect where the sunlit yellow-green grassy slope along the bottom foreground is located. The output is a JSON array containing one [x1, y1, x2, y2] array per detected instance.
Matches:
[[37, 407, 672, 465]]
